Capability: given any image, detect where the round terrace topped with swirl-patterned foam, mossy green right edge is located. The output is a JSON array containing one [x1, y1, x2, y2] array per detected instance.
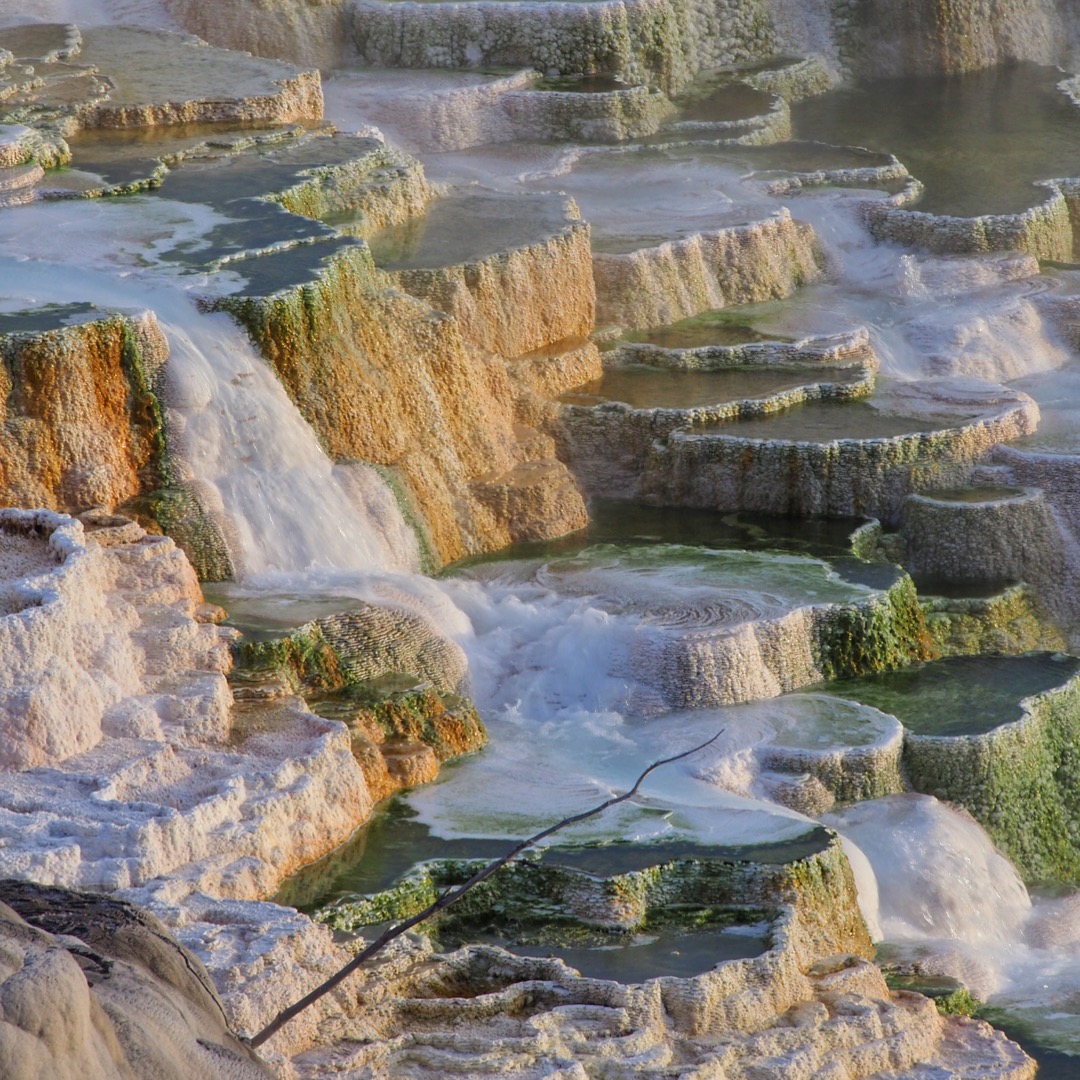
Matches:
[[455, 544, 923, 712]]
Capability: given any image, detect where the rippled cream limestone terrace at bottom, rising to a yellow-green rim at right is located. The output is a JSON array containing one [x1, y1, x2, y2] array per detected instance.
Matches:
[[293, 841, 1034, 1080]]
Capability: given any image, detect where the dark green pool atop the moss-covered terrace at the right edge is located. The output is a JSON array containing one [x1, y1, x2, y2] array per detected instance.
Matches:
[[821, 652, 1080, 735]]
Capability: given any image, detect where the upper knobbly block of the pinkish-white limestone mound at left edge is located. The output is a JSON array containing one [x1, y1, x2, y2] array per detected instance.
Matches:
[[0, 510, 221, 770]]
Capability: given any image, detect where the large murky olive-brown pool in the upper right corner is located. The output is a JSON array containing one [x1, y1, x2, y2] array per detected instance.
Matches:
[[792, 64, 1080, 216]]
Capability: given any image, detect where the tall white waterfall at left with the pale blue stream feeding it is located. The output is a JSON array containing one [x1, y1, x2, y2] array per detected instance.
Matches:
[[0, 199, 419, 580]]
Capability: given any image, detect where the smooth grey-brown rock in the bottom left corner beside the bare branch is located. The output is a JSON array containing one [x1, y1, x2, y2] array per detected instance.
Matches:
[[0, 879, 272, 1080]]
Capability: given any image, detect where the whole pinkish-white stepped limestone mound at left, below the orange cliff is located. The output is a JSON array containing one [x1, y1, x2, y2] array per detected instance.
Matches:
[[0, 510, 370, 897]]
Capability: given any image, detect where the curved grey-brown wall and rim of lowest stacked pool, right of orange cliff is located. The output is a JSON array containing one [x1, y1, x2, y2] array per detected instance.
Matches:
[[643, 380, 1039, 525]]
